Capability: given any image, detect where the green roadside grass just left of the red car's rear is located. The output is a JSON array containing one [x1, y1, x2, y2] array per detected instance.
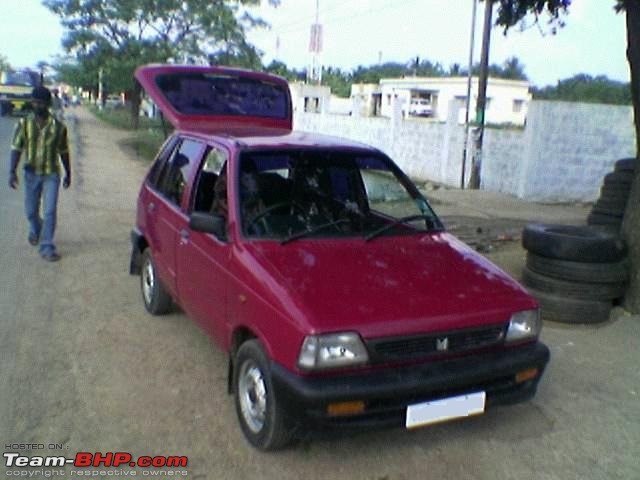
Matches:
[[89, 105, 173, 161]]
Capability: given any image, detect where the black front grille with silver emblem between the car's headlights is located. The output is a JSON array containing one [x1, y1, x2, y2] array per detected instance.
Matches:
[[367, 325, 506, 363]]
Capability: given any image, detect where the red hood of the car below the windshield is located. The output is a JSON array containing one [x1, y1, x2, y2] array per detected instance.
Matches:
[[248, 232, 537, 338]]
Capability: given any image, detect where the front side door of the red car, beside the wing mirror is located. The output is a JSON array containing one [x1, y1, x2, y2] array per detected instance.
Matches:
[[177, 146, 231, 344]]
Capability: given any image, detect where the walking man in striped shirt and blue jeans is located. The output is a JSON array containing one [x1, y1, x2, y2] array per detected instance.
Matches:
[[9, 87, 71, 262]]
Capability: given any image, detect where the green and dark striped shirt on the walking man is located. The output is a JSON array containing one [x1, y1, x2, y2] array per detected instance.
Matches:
[[11, 114, 69, 175]]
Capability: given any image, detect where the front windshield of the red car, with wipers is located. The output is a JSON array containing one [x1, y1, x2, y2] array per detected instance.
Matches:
[[238, 149, 442, 243]]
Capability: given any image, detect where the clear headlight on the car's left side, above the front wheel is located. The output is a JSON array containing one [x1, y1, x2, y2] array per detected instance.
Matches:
[[298, 332, 369, 370]]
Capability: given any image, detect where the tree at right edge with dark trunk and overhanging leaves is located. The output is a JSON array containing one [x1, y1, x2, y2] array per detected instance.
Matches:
[[496, 0, 640, 313]]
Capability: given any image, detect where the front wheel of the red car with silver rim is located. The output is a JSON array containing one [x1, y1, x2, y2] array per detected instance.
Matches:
[[233, 339, 293, 451]]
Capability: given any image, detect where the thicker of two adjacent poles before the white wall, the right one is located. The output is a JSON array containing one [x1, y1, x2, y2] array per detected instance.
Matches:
[[469, 0, 494, 189]]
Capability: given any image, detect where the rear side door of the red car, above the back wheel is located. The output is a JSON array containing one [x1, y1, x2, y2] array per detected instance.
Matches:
[[145, 138, 204, 301]]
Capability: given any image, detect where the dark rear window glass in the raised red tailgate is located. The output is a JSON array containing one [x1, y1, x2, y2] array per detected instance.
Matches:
[[156, 73, 290, 119]]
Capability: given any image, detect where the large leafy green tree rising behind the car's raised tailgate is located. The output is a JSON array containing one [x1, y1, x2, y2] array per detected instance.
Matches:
[[43, 0, 279, 115]]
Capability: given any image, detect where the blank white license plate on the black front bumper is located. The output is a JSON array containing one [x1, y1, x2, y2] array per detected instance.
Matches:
[[405, 392, 487, 428]]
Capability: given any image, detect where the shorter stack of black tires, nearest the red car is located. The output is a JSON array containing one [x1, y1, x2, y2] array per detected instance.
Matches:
[[522, 224, 629, 323]]
